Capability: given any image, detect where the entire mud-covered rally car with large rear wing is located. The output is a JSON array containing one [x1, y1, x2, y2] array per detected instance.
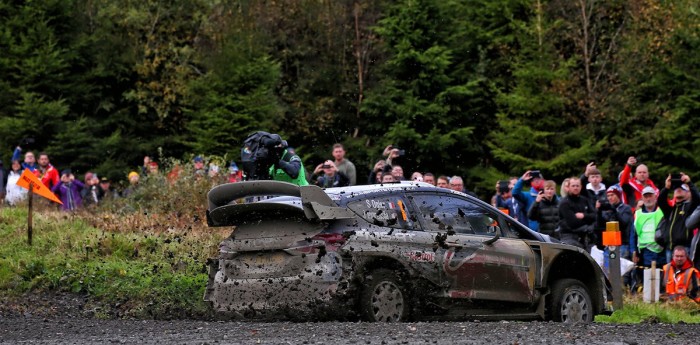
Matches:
[[204, 181, 609, 322]]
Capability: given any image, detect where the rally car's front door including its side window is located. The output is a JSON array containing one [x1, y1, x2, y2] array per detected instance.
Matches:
[[412, 192, 535, 303]]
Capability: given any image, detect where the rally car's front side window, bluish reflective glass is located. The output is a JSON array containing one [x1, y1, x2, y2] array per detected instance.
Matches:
[[413, 193, 498, 235]]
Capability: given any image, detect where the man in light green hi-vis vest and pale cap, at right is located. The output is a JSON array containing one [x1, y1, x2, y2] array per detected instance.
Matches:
[[633, 186, 666, 267]]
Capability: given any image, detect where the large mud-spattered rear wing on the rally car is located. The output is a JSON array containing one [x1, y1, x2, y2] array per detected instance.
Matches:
[[207, 180, 355, 227]]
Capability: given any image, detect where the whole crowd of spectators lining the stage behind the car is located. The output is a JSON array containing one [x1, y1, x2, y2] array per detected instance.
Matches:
[[0, 142, 700, 301]]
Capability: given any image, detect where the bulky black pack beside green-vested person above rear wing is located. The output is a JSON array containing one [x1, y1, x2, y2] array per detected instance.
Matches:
[[241, 131, 286, 180]]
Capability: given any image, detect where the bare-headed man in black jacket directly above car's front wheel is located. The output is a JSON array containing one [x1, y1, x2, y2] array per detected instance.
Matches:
[[559, 177, 596, 249]]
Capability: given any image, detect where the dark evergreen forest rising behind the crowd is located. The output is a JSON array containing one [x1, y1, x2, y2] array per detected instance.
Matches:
[[0, 0, 700, 195]]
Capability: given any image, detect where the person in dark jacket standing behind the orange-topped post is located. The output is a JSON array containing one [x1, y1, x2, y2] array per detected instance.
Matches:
[[595, 184, 637, 288]]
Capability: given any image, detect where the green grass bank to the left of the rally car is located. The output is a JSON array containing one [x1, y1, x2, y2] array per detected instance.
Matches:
[[0, 207, 224, 318]]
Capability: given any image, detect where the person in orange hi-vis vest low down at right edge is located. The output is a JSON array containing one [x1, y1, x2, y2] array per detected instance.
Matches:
[[663, 245, 700, 303]]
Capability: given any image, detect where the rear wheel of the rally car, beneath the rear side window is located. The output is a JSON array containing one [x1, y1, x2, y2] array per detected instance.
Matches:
[[359, 268, 410, 322]]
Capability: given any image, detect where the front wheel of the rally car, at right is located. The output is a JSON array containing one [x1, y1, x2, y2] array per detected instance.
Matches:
[[550, 279, 595, 323]]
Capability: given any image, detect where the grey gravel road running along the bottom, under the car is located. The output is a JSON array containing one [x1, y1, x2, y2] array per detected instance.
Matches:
[[0, 317, 700, 345]]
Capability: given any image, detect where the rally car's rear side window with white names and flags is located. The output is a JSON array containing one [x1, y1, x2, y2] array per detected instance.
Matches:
[[348, 196, 420, 230]]
